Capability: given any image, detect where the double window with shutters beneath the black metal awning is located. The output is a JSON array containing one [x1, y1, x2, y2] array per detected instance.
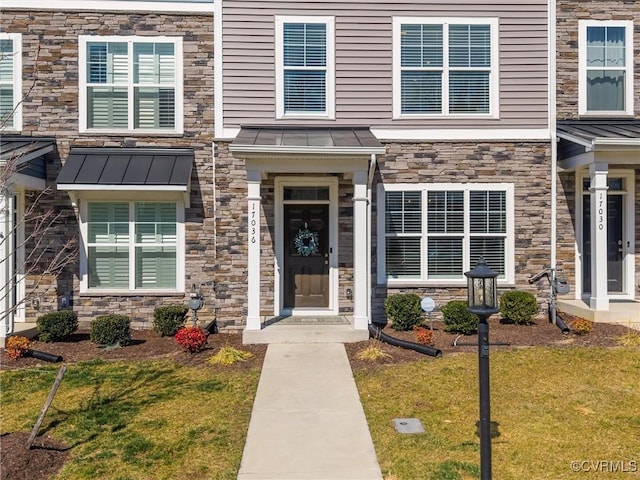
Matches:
[[83, 201, 181, 290]]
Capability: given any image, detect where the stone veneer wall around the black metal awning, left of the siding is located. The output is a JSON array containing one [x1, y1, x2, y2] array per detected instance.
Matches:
[[0, 10, 217, 326]]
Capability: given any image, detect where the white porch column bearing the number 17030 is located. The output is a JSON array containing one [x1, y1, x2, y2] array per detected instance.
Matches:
[[589, 163, 609, 310]]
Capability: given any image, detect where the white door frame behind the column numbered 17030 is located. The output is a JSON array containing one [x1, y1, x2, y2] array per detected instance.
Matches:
[[575, 169, 636, 303]]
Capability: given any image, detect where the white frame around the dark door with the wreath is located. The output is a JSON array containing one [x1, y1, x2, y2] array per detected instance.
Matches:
[[273, 176, 339, 316]]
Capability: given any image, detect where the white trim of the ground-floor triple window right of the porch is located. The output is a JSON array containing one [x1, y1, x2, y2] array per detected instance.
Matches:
[[377, 183, 515, 287]]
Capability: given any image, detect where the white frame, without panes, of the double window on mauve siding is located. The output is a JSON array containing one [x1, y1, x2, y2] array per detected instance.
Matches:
[[393, 17, 500, 119]]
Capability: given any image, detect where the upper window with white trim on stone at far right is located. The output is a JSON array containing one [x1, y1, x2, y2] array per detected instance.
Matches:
[[579, 20, 633, 115]]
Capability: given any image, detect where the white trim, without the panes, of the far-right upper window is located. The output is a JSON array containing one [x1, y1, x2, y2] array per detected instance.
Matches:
[[578, 20, 635, 116]]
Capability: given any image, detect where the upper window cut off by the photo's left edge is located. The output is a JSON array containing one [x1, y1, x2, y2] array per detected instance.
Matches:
[[0, 32, 22, 131]]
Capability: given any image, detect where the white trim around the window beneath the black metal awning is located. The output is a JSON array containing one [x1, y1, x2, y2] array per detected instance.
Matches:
[[79, 191, 186, 296]]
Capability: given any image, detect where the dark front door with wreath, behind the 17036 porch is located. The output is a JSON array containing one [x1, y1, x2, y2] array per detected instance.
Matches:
[[284, 204, 329, 308]]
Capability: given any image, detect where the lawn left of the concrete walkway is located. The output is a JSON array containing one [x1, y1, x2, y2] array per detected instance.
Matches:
[[0, 361, 260, 480]]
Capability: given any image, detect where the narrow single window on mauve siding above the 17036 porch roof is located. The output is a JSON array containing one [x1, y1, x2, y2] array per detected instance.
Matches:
[[275, 17, 335, 118]]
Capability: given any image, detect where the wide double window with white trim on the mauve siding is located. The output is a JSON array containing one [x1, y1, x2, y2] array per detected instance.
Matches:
[[393, 17, 498, 118]]
